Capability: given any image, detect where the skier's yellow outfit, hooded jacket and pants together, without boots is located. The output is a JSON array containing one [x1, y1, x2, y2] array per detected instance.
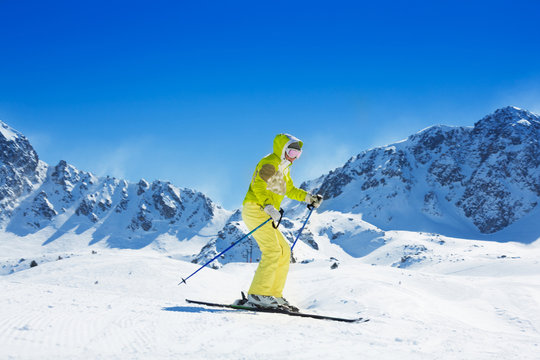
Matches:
[[242, 134, 307, 297]]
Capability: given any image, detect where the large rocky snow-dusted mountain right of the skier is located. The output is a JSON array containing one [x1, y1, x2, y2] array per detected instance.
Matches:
[[302, 107, 540, 242]]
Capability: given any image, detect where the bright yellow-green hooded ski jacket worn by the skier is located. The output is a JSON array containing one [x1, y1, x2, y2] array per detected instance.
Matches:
[[243, 134, 307, 210]]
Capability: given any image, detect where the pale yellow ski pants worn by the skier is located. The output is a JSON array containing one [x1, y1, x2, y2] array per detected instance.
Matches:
[[242, 202, 291, 297]]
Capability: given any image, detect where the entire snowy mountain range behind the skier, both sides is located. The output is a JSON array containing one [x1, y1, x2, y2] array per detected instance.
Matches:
[[0, 107, 540, 267]]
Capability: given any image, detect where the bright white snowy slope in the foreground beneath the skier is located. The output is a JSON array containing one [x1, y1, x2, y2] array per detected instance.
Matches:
[[0, 232, 540, 359]]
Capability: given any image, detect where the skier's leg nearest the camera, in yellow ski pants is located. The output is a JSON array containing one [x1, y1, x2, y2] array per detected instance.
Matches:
[[242, 203, 282, 296]]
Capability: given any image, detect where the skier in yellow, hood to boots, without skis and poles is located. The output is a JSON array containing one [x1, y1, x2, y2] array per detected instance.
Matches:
[[242, 134, 322, 311]]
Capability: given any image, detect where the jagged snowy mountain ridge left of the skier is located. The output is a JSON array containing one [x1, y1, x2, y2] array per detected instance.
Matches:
[[0, 119, 231, 251]]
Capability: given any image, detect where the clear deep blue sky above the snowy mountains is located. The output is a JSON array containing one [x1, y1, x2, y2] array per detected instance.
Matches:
[[0, 0, 540, 209]]
